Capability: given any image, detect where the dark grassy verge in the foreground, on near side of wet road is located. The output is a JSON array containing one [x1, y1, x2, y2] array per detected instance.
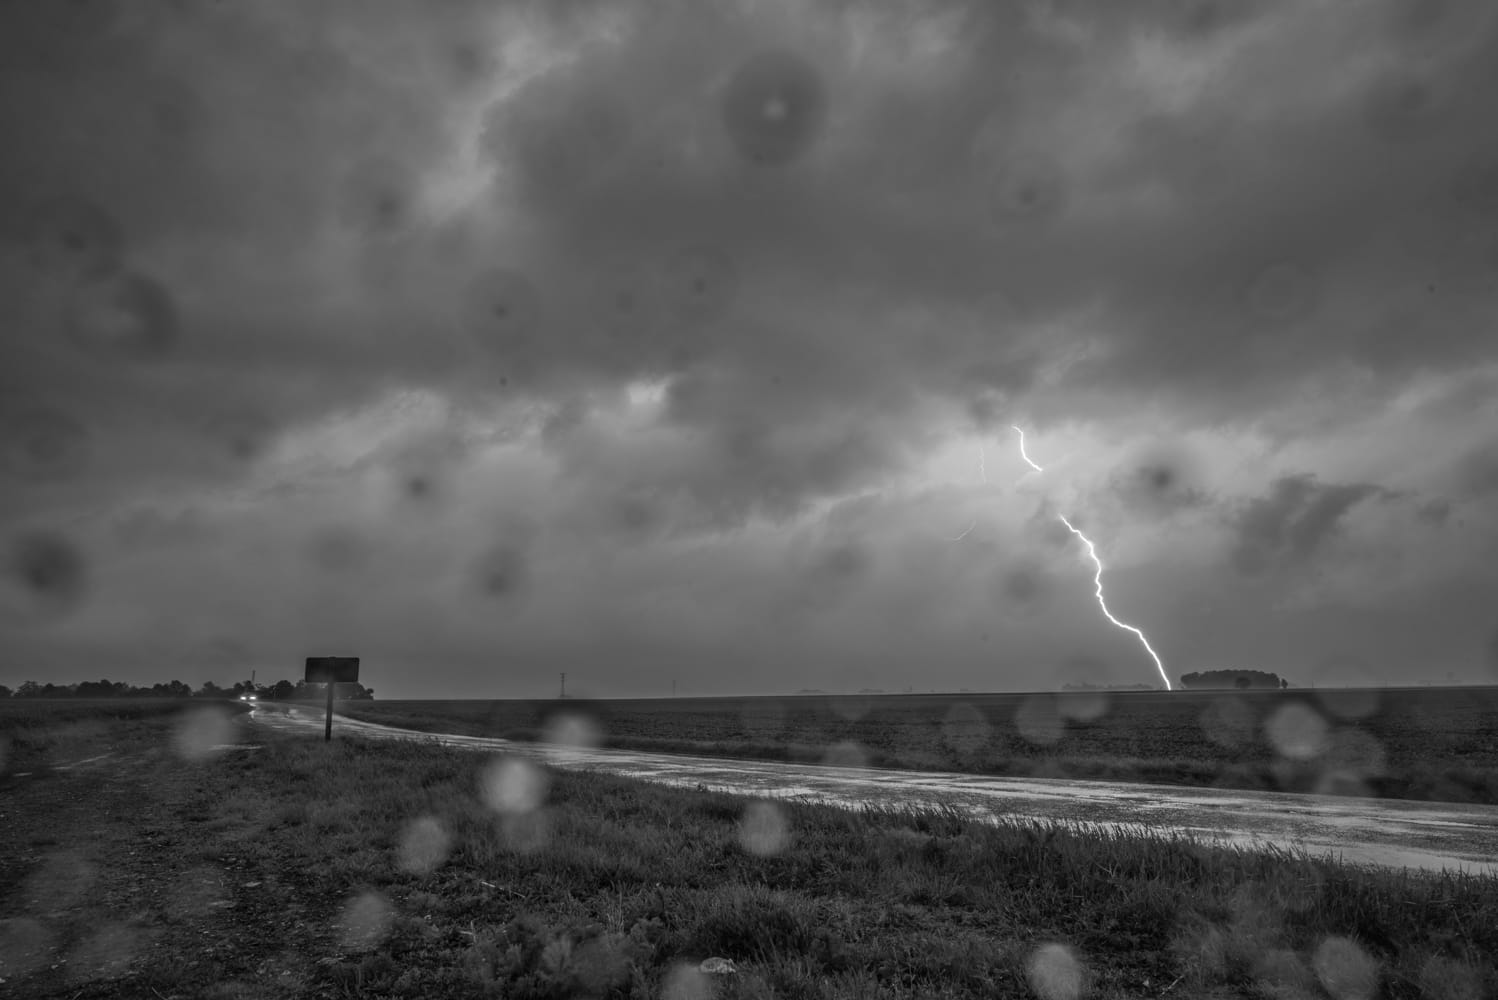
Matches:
[[0, 710, 1498, 1000]]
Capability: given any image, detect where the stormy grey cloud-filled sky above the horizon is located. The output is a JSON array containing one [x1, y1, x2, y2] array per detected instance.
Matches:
[[0, 0, 1498, 698]]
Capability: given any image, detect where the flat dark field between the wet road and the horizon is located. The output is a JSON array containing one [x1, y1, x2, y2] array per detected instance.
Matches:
[[339, 687, 1498, 804]]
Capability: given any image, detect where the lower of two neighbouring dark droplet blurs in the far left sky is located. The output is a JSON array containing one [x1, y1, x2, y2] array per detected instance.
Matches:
[[64, 274, 180, 362]]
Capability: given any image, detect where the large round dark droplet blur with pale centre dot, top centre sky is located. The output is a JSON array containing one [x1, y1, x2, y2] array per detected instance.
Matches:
[[721, 49, 827, 166]]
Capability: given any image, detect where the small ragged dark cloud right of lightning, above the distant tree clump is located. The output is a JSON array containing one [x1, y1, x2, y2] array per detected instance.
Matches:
[[1233, 475, 1390, 575]]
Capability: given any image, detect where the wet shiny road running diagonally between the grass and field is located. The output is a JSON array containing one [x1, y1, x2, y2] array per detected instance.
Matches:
[[250, 708, 1498, 874]]
